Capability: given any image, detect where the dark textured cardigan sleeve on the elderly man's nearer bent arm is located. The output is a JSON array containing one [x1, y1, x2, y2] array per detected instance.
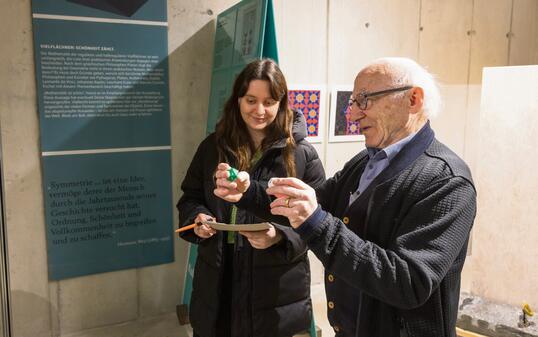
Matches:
[[297, 177, 476, 309]]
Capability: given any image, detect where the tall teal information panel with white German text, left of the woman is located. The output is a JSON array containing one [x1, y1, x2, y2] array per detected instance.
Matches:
[[32, 0, 173, 280]]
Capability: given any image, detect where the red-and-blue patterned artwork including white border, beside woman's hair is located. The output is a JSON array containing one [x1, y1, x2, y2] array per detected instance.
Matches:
[[288, 84, 327, 143]]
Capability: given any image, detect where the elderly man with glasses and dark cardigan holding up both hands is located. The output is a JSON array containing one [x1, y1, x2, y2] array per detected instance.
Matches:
[[215, 58, 476, 337]]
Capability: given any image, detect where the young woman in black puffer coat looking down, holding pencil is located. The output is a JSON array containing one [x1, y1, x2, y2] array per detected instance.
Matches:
[[177, 59, 325, 337]]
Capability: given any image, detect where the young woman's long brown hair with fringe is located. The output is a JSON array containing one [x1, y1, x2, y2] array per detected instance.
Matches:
[[215, 59, 296, 177]]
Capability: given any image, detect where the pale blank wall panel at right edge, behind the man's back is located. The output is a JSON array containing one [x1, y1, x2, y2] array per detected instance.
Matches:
[[468, 65, 538, 307]]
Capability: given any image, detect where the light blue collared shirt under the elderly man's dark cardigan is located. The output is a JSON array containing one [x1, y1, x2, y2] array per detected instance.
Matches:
[[349, 133, 416, 205]]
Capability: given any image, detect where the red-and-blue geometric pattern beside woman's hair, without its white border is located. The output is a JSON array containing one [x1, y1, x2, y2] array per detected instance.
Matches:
[[288, 90, 321, 137]]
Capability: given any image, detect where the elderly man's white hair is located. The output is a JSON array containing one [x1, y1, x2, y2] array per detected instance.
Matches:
[[366, 57, 442, 118]]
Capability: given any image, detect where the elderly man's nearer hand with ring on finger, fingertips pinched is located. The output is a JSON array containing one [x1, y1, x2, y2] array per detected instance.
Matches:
[[267, 178, 318, 228]]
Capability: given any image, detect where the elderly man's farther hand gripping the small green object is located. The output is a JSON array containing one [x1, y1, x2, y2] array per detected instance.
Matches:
[[213, 163, 250, 202]]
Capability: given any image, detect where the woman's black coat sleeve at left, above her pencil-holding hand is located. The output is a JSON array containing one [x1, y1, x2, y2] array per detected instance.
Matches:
[[176, 141, 213, 243]]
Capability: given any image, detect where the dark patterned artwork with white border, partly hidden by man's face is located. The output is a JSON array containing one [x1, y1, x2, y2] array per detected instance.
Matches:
[[329, 86, 364, 142]]
